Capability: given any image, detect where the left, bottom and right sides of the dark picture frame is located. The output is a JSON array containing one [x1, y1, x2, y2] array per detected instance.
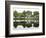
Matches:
[[5, 1, 45, 37]]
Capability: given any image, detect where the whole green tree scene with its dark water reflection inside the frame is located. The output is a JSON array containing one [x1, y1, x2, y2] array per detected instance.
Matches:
[[13, 10, 39, 28]]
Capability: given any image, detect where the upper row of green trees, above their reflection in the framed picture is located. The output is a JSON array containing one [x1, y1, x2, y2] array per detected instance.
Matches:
[[14, 10, 39, 17]]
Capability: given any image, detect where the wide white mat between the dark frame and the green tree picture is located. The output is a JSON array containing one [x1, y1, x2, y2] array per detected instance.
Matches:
[[10, 5, 43, 34]]
